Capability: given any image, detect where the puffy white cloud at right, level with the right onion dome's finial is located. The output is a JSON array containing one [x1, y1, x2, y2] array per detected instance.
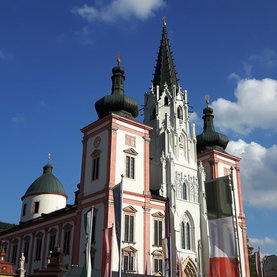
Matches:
[[211, 78, 277, 134]]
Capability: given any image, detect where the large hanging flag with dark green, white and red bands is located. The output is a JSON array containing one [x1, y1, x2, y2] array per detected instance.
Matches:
[[205, 176, 239, 277]]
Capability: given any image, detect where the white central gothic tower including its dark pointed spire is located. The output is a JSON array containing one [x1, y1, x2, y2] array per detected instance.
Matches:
[[144, 22, 204, 276]]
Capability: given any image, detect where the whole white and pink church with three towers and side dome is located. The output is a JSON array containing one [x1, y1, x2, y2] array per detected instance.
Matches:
[[0, 22, 250, 277]]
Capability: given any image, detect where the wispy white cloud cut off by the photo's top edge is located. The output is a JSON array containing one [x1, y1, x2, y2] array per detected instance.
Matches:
[[72, 0, 165, 22]]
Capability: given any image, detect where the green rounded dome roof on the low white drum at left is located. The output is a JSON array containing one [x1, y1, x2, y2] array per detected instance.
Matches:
[[23, 164, 67, 198]]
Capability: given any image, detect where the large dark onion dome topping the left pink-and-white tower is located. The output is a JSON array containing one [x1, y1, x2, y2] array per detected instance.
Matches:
[[95, 60, 138, 119]]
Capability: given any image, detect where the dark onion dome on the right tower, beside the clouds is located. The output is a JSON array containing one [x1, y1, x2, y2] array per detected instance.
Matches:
[[197, 107, 229, 154]]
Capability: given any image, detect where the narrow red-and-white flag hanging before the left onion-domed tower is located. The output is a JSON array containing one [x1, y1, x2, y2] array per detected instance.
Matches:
[[101, 228, 113, 277]]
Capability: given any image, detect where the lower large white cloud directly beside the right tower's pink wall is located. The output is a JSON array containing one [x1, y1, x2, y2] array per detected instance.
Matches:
[[227, 139, 277, 209]]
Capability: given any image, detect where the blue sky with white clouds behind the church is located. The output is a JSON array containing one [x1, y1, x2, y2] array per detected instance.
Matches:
[[0, 0, 277, 254]]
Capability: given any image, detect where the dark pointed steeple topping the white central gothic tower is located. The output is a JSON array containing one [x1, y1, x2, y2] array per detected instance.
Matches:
[[153, 21, 178, 88]]
